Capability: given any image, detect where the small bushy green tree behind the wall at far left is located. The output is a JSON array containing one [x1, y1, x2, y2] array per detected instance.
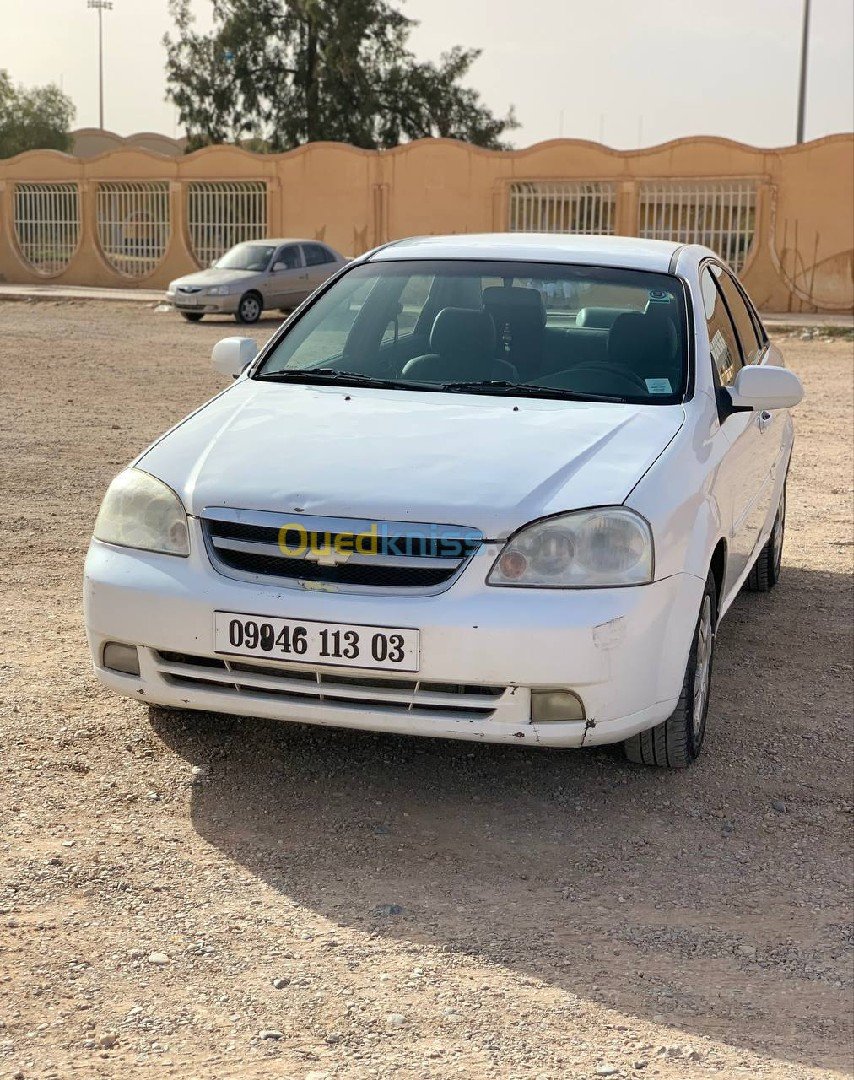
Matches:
[[0, 71, 74, 158]]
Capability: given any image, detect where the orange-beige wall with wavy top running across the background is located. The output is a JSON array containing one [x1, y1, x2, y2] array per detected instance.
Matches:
[[0, 134, 854, 311]]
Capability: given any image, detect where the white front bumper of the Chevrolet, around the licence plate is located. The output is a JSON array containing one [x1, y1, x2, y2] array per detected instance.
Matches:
[[84, 537, 703, 746]]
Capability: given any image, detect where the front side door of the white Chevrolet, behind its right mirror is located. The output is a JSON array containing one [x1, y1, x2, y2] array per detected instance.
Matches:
[[701, 262, 772, 583]]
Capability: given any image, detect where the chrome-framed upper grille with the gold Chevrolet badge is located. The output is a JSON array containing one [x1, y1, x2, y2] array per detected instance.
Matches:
[[202, 508, 483, 593]]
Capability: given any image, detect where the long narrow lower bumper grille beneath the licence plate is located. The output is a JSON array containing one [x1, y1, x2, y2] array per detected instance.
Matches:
[[154, 652, 507, 720]]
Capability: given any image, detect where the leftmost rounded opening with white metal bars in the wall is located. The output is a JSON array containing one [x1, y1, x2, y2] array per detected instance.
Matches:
[[14, 183, 80, 276]]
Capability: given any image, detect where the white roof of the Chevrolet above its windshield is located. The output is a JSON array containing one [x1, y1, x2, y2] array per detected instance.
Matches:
[[369, 232, 715, 272]]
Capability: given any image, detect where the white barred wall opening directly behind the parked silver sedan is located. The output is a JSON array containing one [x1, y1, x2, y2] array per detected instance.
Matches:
[[187, 180, 267, 267]]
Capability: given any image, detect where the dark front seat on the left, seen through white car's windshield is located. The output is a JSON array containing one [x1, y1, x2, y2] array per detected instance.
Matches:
[[402, 308, 516, 382]]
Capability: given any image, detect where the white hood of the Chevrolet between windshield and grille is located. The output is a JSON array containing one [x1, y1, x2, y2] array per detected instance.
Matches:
[[136, 378, 683, 539]]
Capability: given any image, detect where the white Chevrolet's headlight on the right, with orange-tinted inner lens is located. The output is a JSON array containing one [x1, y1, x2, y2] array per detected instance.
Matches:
[[486, 507, 653, 589]]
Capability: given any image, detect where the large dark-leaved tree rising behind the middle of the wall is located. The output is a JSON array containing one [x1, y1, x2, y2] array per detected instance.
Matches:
[[163, 0, 518, 151]]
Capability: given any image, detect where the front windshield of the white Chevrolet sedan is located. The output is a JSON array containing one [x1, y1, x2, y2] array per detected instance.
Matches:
[[255, 260, 688, 405]]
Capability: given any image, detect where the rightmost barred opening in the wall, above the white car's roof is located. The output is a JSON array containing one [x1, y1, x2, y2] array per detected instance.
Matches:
[[638, 180, 756, 272]]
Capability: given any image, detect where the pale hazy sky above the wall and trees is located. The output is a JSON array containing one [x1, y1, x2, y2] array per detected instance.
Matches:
[[0, 0, 854, 149]]
